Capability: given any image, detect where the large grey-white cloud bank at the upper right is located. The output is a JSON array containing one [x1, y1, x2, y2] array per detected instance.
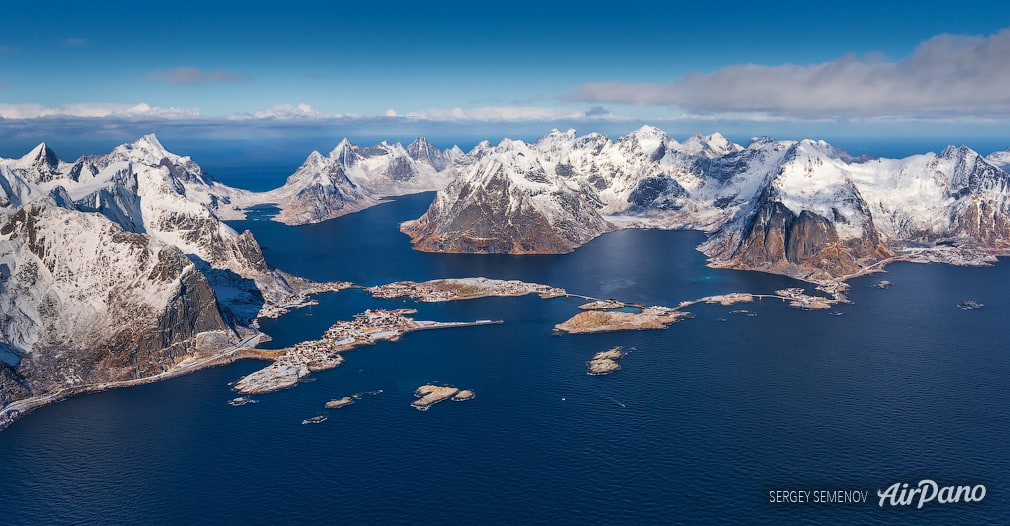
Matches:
[[569, 28, 1010, 118]]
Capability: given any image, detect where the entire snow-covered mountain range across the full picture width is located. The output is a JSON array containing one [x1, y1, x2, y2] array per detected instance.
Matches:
[[0, 126, 1010, 426]]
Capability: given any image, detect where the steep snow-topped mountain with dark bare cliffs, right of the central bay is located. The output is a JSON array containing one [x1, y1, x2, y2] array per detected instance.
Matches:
[[700, 140, 893, 280]]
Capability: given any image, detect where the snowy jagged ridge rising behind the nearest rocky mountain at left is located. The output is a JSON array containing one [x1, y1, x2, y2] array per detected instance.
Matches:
[[0, 135, 304, 324]]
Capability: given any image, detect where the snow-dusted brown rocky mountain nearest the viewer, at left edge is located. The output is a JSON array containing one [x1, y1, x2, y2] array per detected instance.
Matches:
[[0, 202, 234, 402]]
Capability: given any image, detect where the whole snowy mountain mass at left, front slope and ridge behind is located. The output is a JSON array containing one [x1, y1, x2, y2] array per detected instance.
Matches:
[[0, 135, 327, 426]]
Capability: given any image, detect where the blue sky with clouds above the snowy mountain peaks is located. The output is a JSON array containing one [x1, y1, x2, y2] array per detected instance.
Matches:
[[0, 0, 1010, 155]]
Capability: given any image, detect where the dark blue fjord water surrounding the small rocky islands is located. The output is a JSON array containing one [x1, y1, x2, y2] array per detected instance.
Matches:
[[0, 194, 1010, 524]]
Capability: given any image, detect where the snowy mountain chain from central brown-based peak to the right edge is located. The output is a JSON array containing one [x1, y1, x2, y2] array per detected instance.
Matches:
[[401, 126, 1010, 281]]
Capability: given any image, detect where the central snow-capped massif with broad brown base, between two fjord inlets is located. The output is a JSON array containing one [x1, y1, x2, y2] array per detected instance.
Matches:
[[401, 126, 743, 252]]
